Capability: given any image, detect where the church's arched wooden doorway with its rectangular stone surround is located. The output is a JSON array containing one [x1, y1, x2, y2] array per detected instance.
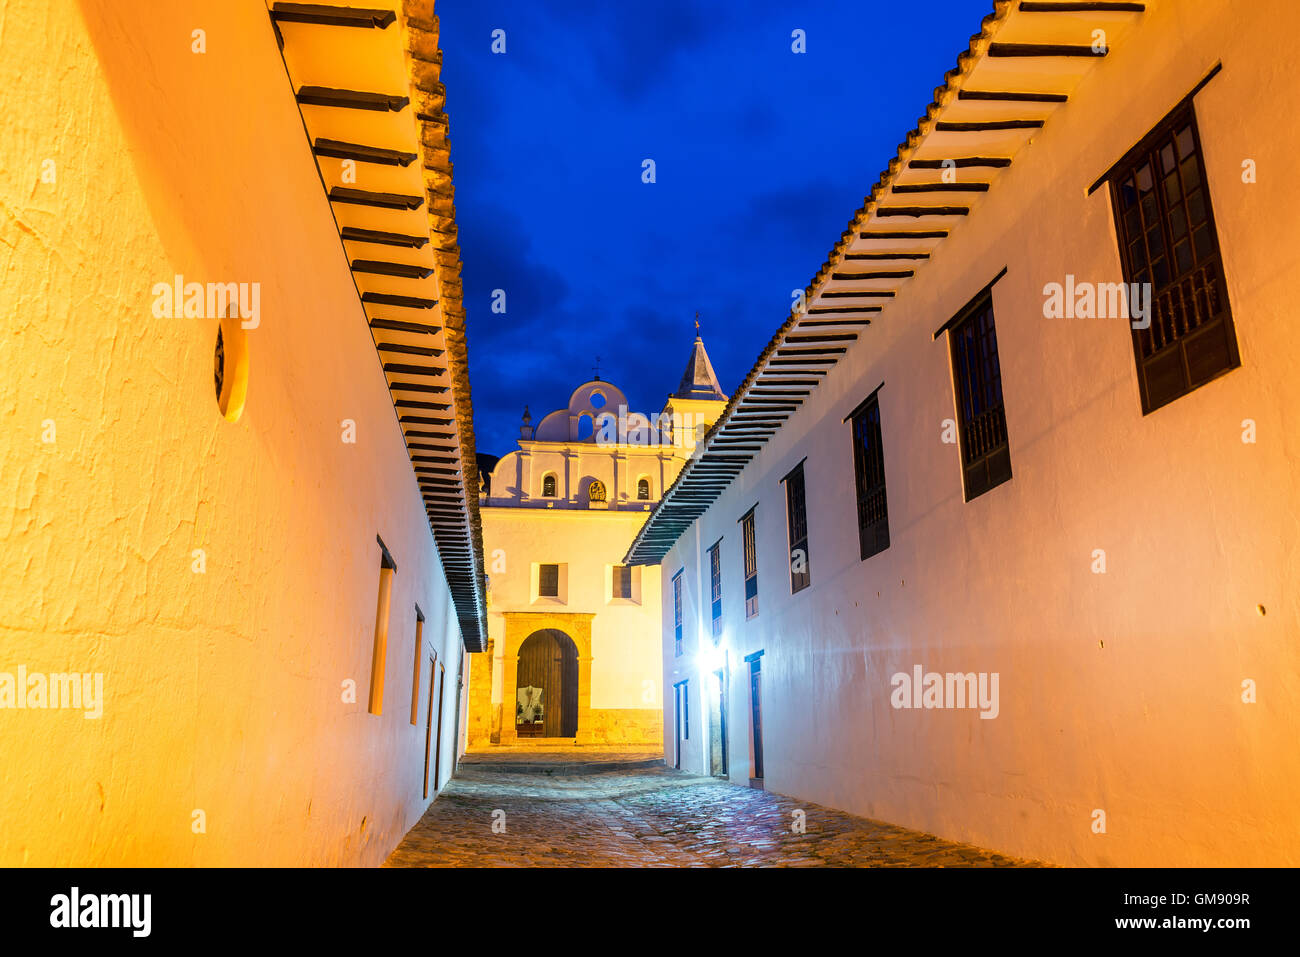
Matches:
[[501, 611, 594, 745]]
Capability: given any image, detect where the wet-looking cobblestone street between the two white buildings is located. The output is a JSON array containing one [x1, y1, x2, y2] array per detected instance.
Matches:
[[385, 755, 1034, 867]]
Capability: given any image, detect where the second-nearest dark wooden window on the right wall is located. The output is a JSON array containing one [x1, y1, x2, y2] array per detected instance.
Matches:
[[948, 287, 1011, 502]]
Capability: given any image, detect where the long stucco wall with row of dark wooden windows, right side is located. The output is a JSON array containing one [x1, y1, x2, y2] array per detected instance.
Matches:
[[663, 0, 1300, 865]]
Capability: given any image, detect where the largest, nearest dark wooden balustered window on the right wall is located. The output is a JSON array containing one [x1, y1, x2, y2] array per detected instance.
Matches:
[[1110, 101, 1242, 415]]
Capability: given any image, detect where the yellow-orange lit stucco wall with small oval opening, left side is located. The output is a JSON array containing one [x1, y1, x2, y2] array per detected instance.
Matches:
[[0, 0, 464, 866]]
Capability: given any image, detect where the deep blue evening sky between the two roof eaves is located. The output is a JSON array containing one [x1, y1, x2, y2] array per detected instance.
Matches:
[[437, 0, 992, 455]]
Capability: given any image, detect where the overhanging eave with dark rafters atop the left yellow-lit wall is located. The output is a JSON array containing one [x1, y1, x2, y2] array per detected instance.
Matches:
[[270, 0, 488, 651]]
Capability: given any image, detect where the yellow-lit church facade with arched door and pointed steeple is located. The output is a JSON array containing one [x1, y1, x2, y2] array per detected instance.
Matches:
[[468, 335, 727, 749]]
